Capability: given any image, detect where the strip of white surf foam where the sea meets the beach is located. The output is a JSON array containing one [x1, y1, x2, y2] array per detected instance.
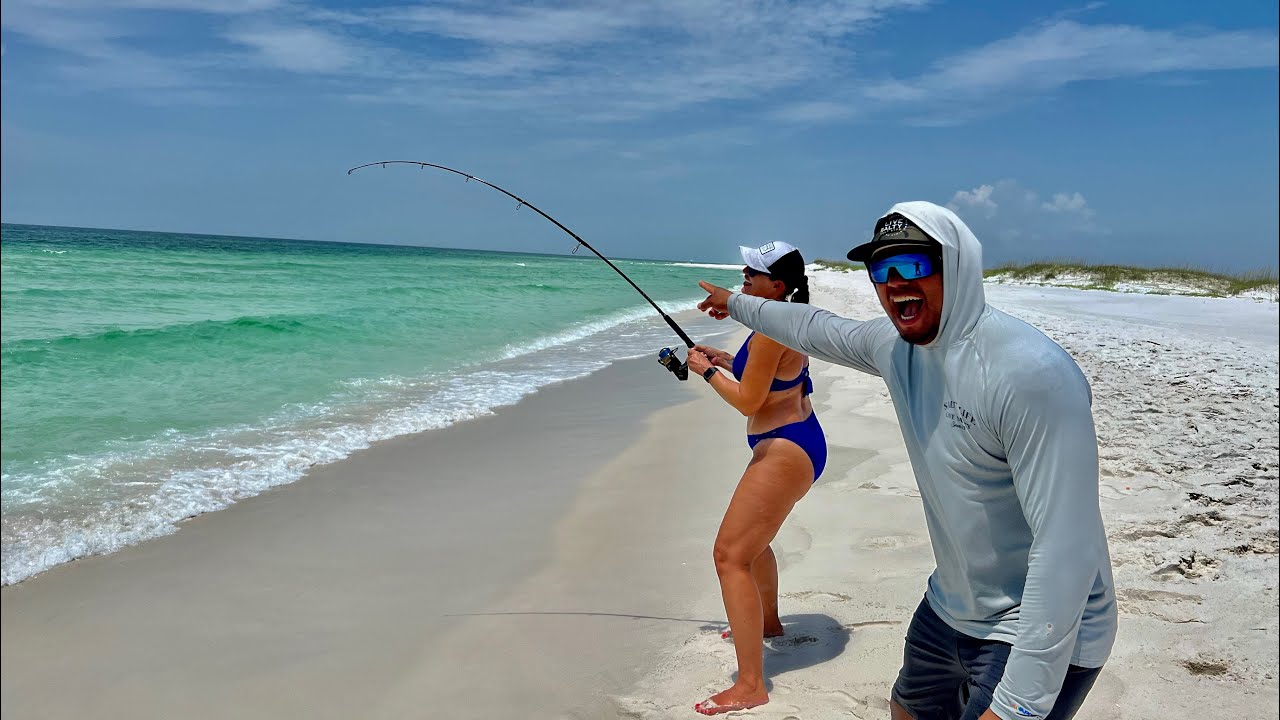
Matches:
[[4, 299, 742, 587]]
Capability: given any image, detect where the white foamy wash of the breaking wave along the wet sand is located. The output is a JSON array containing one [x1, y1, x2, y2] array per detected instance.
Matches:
[[0, 299, 731, 584]]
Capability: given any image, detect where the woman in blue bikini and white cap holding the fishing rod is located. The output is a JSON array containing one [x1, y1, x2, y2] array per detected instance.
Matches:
[[689, 242, 827, 715]]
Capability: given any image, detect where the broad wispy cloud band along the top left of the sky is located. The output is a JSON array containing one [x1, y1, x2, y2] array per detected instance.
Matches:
[[4, 0, 928, 113]]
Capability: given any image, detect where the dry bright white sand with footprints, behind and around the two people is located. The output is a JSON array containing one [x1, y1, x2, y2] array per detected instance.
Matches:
[[618, 272, 1280, 720]]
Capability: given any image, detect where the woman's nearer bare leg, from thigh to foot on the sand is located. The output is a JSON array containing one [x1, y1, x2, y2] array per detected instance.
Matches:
[[694, 439, 813, 715]]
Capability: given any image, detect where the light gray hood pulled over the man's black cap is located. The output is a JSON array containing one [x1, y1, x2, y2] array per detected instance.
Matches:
[[870, 200, 987, 347]]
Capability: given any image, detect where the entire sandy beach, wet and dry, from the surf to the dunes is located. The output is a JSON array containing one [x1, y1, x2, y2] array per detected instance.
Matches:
[[0, 270, 1280, 720]]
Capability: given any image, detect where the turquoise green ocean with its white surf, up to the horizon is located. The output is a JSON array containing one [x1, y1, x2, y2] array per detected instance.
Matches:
[[0, 224, 739, 584]]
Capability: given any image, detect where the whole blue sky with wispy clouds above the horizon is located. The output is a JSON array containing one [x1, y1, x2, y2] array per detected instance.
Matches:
[[0, 0, 1280, 270]]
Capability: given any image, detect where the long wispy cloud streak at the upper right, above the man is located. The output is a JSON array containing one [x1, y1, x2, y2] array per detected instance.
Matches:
[[865, 19, 1280, 124]]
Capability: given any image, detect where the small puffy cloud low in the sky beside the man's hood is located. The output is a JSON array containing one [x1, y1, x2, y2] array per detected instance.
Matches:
[[947, 179, 1110, 264]]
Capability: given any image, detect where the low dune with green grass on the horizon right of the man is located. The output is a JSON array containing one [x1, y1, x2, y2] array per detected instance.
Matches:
[[983, 261, 1276, 297]]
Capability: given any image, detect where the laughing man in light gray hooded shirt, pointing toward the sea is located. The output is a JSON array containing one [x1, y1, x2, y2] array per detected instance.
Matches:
[[699, 202, 1116, 720]]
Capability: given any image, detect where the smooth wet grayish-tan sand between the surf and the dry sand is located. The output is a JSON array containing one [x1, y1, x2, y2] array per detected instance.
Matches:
[[0, 345, 742, 717]]
